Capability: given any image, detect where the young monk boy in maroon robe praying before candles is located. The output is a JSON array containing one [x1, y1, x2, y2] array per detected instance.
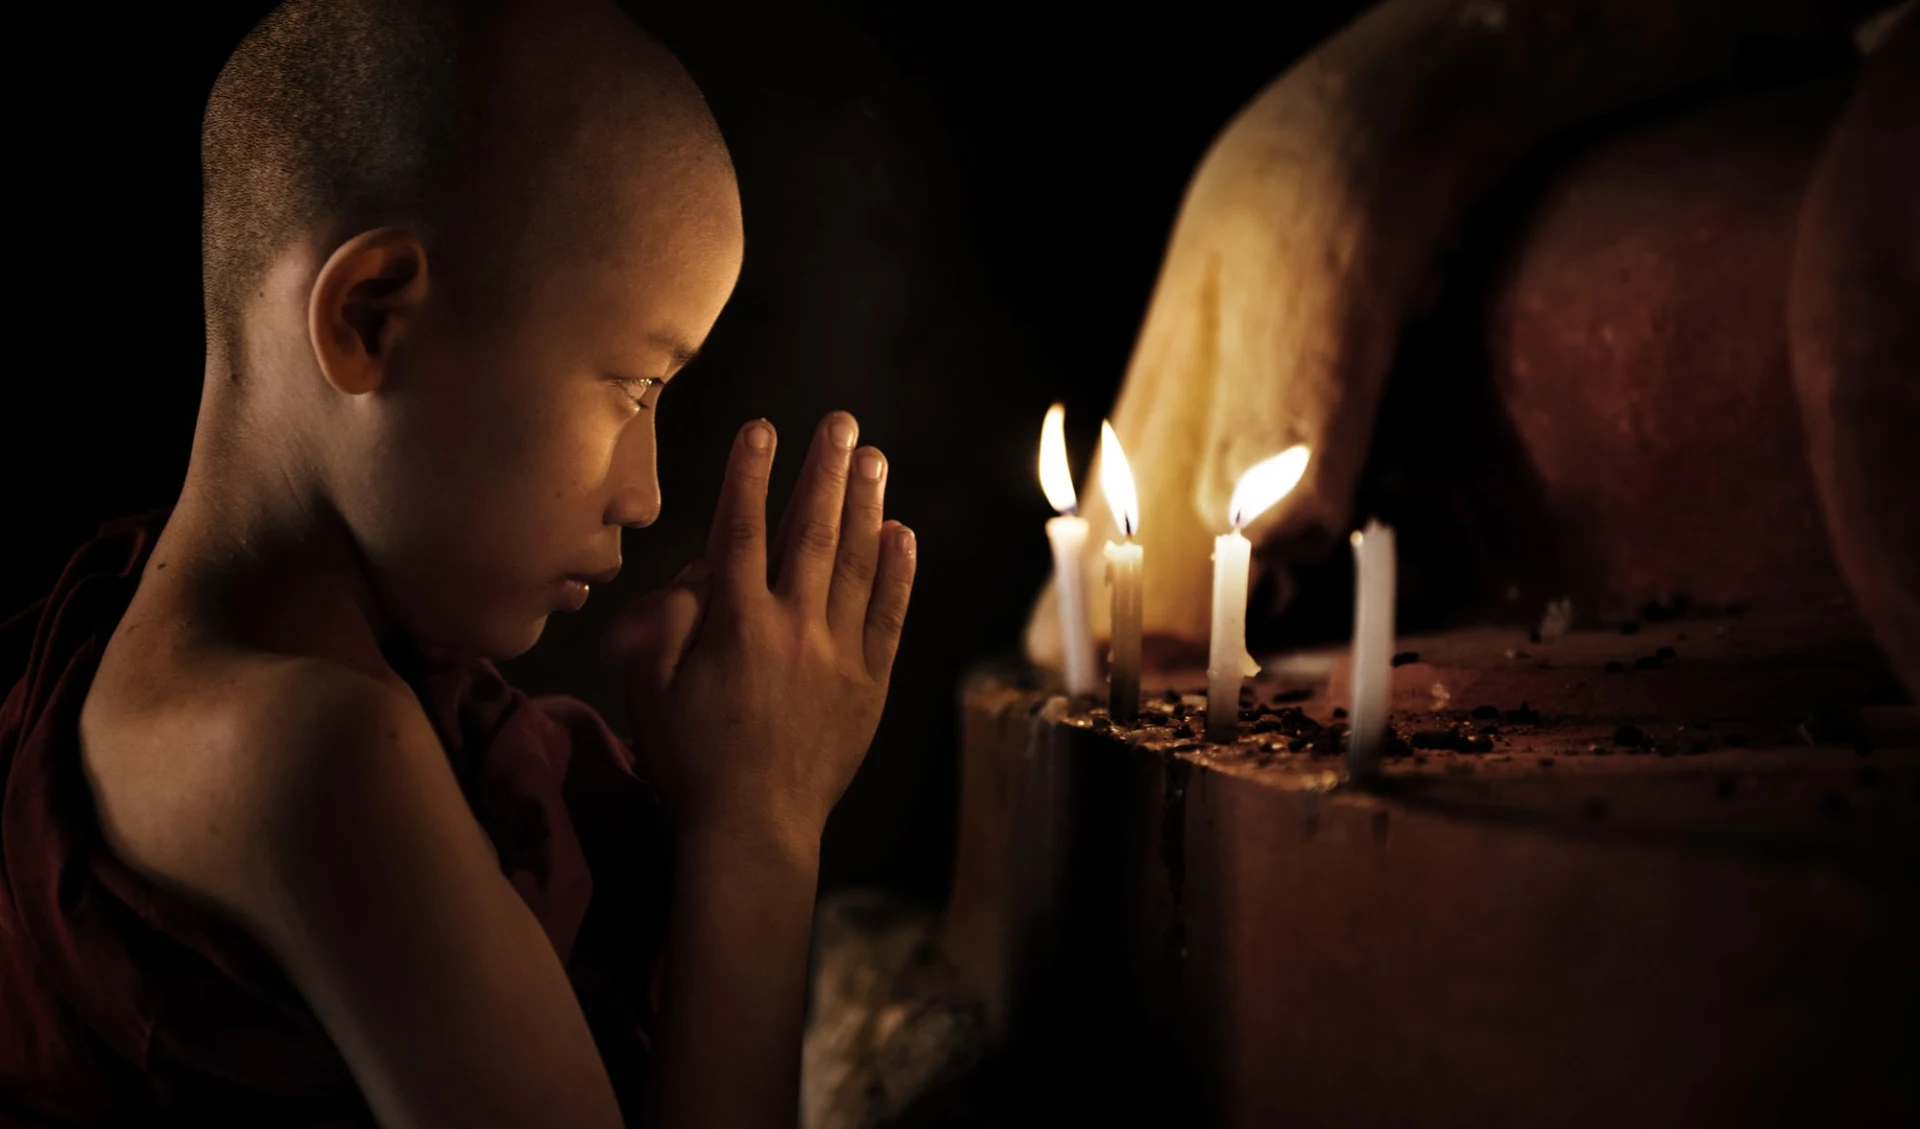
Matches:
[[0, 0, 914, 1129]]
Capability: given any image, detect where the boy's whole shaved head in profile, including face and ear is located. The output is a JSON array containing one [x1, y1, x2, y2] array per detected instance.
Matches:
[[182, 0, 743, 657]]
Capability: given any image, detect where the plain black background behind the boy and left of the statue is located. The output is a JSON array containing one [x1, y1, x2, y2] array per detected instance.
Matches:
[[15, 0, 1357, 899]]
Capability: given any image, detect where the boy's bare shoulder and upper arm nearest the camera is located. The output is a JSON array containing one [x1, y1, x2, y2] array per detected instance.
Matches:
[[83, 657, 618, 1129]]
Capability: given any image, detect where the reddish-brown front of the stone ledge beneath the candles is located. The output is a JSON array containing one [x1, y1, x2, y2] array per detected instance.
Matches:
[[945, 664, 1920, 1129]]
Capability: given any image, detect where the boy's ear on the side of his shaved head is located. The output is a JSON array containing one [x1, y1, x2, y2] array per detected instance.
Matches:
[[307, 227, 426, 396]]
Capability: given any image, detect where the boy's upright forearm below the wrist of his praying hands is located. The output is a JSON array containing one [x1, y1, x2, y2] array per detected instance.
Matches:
[[647, 814, 820, 1129]]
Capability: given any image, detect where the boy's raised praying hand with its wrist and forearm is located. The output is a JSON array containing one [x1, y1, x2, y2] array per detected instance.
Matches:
[[622, 413, 916, 1129]]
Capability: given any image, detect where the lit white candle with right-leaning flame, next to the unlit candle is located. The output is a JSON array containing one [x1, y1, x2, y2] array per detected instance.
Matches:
[[1206, 447, 1308, 743]]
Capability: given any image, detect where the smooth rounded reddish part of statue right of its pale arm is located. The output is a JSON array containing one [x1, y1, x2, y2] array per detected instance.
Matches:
[[1486, 81, 1845, 614]]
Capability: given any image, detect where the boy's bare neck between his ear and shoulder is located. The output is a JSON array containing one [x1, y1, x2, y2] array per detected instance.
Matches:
[[148, 351, 390, 664]]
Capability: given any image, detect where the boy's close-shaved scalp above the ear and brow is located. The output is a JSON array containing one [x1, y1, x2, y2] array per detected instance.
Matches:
[[202, 0, 732, 353]]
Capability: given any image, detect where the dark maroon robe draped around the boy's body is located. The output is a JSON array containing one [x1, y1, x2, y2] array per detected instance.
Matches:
[[0, 513, 666, 1127]]
